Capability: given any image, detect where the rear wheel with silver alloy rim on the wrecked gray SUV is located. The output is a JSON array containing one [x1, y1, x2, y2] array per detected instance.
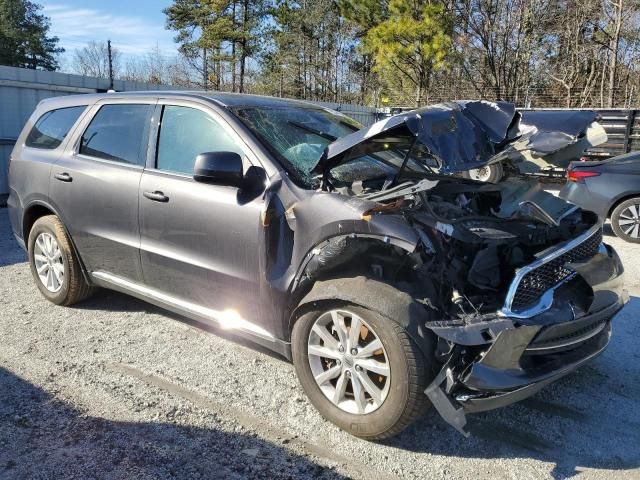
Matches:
[[27, 215, 93, 305]]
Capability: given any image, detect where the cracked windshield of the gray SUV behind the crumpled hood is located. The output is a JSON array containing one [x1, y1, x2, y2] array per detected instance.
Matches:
[[233, 107, 362, 187]]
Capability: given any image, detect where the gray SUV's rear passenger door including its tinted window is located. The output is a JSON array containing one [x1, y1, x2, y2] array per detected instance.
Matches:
[[50, 98, 156, 281]]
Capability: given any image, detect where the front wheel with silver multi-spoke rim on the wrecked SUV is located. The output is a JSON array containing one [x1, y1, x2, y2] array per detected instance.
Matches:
[[292, 301, 431, 440]]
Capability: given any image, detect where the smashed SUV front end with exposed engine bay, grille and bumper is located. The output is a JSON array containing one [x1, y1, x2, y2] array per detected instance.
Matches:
[[342, 175, 628, 433]]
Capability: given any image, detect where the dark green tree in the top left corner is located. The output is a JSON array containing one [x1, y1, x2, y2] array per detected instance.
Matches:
[[0, 0, 64, 70]]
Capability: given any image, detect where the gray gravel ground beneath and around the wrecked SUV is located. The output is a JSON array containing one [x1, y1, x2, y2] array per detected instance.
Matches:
[[0, 209, 640, 479]]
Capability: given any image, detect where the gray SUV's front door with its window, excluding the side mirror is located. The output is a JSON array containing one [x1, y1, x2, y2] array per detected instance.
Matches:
[[139, 101, 262, 327]]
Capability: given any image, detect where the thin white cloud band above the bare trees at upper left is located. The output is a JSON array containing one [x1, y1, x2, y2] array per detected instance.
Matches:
[[44, 3, 176, 55]]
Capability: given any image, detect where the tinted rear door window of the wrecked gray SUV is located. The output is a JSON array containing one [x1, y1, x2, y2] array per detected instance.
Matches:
[[80, 104, 151, 165]]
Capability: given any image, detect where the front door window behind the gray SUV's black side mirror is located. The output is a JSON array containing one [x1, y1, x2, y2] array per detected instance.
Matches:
[[156, 105, 244, 175]]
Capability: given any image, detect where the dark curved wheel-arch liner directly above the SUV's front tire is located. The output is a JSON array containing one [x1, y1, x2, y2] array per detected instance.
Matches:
[[289, 276, 435, 358]]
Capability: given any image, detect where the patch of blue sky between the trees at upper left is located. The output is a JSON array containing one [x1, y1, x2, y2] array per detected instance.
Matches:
[[38, 0, 177, 60]]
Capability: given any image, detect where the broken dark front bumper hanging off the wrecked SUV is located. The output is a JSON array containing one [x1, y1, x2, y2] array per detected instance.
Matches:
[[425, 247, 629, 435]]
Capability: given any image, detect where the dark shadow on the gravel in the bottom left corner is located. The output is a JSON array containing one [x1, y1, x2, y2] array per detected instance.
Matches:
[[0, 368, 344, 479]]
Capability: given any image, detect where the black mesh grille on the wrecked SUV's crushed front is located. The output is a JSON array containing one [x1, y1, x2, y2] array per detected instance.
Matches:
[[511, 228, 602, 312]]
